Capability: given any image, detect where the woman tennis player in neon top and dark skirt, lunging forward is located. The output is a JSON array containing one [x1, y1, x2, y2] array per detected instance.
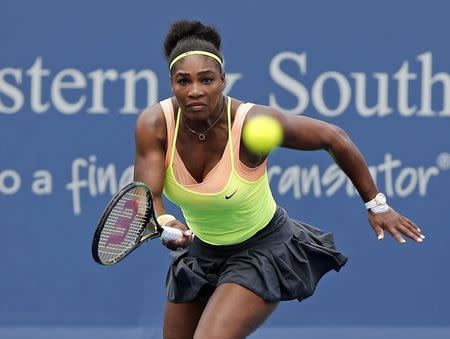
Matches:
[[135, 21, 424, 339]]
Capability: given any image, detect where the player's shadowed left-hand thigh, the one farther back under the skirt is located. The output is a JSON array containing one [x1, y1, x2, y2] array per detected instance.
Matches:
[[163, 301, 206, 339]]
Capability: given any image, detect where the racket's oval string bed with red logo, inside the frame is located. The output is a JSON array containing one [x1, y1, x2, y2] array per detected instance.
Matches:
[[98, 187, 149, 263]]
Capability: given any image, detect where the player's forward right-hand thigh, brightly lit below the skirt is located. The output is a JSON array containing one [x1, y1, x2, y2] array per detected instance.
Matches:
[[194, 283, 278, 339]]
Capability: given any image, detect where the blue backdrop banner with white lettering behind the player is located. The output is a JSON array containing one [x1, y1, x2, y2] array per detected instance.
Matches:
[[0, 0, 450, 339]]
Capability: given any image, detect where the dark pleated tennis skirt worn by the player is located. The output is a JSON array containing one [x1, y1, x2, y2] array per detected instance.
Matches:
[[166, 207, 347, 303]]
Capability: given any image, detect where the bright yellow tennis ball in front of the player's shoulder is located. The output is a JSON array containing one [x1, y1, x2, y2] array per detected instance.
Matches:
[[242, 115, 283, 154]]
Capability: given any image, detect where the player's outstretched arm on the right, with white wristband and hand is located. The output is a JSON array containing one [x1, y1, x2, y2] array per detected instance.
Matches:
[[266, 108, 425, 243]]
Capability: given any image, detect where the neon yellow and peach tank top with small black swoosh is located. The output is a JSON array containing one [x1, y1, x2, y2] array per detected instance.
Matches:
[[161, 97, 276, 245]]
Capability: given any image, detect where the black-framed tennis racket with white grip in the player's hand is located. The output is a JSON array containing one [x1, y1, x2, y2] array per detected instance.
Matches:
[[92, 182, 183, 266]]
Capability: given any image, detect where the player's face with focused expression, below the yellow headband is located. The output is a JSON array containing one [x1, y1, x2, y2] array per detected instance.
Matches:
[[172, 55, 225, 120]]
